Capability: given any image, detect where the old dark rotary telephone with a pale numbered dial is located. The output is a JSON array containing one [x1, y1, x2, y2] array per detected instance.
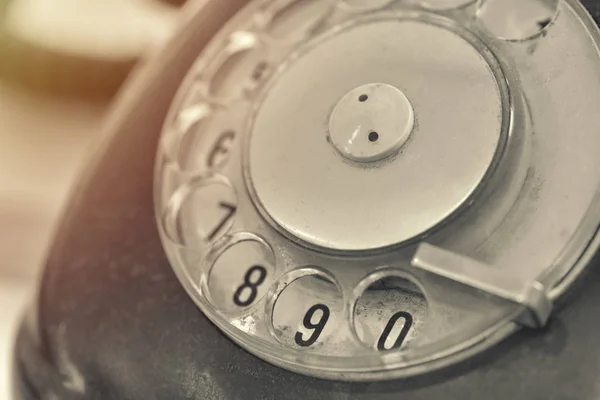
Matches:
[[14, 0, 600, 400]]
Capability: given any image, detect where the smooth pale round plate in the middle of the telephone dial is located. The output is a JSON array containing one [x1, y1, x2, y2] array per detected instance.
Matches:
[[247, 14, 506, 251]]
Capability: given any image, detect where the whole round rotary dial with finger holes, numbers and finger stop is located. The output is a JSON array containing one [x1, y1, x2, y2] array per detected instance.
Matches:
[[155, 0, 600, 380]]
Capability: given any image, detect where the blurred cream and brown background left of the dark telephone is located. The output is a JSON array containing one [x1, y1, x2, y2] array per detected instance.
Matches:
[[0, 0, 188, 400]]
